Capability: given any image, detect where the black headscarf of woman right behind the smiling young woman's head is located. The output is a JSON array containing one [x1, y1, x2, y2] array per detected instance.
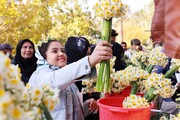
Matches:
[[65, 37, 90, 91]]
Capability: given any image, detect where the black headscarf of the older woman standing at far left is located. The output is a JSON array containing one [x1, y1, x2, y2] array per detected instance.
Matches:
[[12, 39, 37, 84]]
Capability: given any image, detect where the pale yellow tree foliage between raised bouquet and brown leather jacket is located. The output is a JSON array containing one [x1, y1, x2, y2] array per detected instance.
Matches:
[[115, 2, 154, 47]]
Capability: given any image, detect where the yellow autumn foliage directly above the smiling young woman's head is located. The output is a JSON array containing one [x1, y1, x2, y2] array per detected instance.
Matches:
[[49, 0, 98, 42]]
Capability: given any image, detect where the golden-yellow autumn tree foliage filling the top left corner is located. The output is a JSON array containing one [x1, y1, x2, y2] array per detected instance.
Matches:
[[0, 0, 57, 46]]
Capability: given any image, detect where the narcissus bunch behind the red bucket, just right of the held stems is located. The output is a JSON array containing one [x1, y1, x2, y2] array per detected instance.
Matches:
[[108, 65, 149, 94]]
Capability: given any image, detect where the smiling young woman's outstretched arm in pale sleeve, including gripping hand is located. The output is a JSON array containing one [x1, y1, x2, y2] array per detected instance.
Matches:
[[29, 41, 112, 89]]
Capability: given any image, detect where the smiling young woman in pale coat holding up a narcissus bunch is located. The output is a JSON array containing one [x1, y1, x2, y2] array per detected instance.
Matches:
[[29, 40, 112, 120]]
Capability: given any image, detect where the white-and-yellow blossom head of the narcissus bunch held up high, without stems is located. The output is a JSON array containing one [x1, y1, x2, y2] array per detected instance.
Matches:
[[93, 0, 127, 20]]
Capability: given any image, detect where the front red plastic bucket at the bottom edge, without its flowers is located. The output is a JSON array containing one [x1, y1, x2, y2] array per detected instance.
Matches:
[[97, 97, 154, 120]]
